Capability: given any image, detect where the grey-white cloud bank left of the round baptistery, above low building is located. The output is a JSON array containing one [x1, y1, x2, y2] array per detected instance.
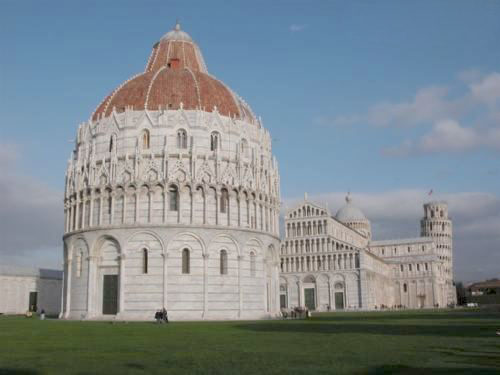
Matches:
[[0, 143, 63, 267]]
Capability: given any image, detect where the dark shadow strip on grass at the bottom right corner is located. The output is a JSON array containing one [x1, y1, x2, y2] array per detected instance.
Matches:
[[361, 365, 498, 375]]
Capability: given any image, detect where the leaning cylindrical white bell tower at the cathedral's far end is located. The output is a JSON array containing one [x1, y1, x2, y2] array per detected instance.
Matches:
[[420, 202, 456, 304]]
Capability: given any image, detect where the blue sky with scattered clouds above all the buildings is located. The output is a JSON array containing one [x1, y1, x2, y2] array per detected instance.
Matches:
[[0, 0, 500, 281]]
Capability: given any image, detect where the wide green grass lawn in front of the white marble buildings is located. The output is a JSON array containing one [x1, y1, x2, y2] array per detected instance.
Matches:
[[0, 310, 500, 375]]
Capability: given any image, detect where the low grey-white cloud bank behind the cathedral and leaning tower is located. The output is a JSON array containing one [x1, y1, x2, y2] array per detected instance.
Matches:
[[285, 189, 500, 281]]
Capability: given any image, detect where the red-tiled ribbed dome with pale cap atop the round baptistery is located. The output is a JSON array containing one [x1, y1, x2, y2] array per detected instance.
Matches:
[[92, 23, 258, 124]]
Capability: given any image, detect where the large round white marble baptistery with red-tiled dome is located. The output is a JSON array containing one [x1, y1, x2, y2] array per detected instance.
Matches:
[[63, 24, 280, 320]]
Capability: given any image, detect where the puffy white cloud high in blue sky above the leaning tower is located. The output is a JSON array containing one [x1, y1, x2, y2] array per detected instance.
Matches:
[[322, 69, 500, 156]]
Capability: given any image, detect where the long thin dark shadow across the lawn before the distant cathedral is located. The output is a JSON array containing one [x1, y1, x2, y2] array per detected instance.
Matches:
[[236, 320, 495, 337]]
